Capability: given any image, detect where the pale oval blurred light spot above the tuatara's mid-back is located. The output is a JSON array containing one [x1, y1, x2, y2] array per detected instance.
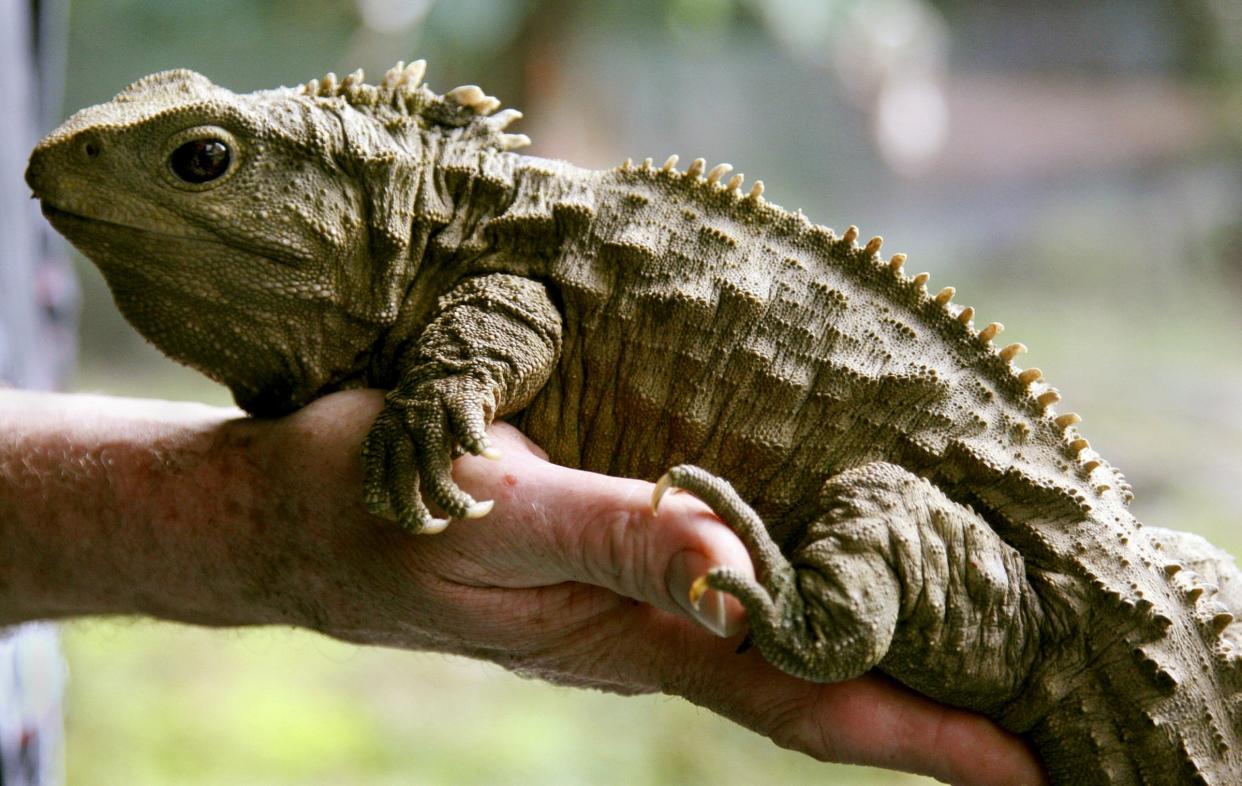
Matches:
[[874, 77, 949, 175]]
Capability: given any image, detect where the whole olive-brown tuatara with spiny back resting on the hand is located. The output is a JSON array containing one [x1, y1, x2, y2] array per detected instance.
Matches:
[[27, 62, 1242, 784]]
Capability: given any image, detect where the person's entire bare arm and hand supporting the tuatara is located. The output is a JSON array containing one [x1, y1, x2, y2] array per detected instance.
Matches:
[[0, 391, 1041, 784]]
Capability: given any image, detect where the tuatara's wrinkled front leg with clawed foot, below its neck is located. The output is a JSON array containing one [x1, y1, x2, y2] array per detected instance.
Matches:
[[363, 273, 561, 533]]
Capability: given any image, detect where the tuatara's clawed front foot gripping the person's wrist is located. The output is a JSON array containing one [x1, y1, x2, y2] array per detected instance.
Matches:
[[363, 375, 499, 534]]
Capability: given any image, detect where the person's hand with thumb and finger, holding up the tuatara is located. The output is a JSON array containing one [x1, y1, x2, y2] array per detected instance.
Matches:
[[247, 391, 1043, 784]]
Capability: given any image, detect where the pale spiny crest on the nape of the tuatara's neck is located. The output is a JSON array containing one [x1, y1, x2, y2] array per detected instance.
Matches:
[[294, 60, 530, 150]]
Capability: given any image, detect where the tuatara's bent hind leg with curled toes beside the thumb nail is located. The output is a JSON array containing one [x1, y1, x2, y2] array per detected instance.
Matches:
[[653, 463, 1041, 711]]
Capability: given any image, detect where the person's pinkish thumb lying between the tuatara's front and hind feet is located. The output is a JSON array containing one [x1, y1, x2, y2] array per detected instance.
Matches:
[[449, 423, 754, 636]]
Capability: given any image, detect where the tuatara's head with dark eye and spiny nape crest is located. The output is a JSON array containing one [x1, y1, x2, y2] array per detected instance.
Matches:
[[26, 62, 526, 415]]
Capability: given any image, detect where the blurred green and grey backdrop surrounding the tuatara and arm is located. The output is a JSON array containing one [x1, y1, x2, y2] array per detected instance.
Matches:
[[53, 0, 1242, 786]]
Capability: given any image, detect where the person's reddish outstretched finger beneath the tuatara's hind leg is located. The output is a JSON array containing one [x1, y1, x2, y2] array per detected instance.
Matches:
[[501, 598, 1046, 786]]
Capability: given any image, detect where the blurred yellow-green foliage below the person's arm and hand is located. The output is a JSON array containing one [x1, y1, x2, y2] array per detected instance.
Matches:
[[66, 622, 924, 786]]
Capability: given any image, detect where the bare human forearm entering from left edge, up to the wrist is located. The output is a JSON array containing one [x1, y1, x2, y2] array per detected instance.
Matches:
[[0, 391, 293, 625]]
